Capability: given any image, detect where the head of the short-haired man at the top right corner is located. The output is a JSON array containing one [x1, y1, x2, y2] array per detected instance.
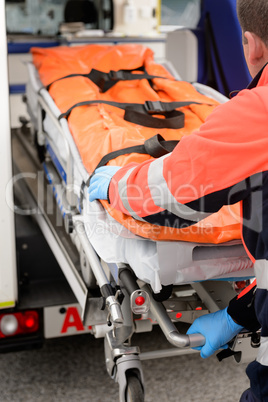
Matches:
[[237, 0, 268, 76]]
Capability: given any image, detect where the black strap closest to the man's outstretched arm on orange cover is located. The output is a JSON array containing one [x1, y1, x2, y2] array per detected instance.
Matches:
[[86, 134, 179, 186]]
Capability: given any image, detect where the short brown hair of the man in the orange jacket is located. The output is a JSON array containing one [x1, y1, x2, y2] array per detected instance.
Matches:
[[237, 0, 268, 46]]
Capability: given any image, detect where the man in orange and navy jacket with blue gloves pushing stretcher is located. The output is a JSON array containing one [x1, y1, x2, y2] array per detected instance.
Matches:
[[89, 0, 268, 401]]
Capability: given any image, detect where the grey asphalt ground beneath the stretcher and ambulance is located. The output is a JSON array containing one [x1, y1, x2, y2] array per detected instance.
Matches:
[[0, 328, 248, 402]]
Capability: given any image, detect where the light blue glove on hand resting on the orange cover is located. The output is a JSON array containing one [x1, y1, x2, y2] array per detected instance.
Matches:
[[88, 166, 121, 201]]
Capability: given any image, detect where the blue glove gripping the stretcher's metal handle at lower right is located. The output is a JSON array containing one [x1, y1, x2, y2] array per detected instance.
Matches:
[[187, 307, 243, 359]]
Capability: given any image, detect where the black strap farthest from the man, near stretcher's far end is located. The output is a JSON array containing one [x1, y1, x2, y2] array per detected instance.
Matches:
[[46, 66, 167, 92]]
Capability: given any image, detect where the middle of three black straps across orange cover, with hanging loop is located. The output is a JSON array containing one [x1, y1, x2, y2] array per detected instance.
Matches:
[[58, 99, 205, 129]]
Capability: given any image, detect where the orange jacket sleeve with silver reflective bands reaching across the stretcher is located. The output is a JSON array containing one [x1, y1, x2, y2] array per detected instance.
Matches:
[[109, 90, 268, 227]]
